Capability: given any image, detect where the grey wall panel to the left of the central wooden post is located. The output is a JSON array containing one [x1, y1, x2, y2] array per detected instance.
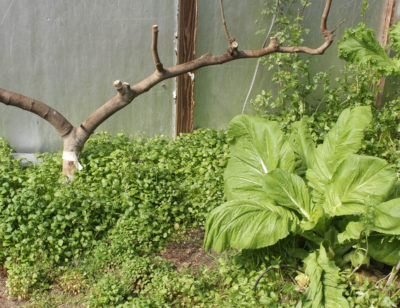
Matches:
[[0, 0, 177, 152]]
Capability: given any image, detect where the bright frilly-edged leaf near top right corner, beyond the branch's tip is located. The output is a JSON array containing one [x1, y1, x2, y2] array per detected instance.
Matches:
[[338, 23, 400, 75]]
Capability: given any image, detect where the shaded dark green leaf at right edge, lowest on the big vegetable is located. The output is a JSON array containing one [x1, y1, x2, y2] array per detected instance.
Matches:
[[368, 235, 400, 266]]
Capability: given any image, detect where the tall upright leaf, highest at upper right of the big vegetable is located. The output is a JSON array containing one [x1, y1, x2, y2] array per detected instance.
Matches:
[[307, 106, 372, 203]]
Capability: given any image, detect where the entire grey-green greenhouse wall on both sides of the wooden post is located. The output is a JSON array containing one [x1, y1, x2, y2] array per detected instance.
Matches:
[[0, 0, 397, 152]]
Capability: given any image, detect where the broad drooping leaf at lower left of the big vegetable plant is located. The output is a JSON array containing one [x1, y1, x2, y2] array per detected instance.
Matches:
[[204, 200, 299, 252]]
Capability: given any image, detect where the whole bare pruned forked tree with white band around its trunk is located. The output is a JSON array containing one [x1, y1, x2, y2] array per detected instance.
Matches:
[[0, 0, 333, 178]]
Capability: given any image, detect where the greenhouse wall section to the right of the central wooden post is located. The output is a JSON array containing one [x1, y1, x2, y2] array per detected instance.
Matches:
[[194, 0, 398, 129]]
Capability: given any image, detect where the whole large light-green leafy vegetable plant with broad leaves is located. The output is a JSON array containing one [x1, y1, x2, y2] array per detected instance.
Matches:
[[204, 107, 400, 307]]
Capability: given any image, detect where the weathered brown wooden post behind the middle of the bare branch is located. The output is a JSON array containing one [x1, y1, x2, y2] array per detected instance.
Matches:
[[175, 0, 198, 136]]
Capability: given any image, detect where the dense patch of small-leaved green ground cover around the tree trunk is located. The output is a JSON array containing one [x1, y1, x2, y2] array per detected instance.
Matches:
[[0, 129, 228, 297]]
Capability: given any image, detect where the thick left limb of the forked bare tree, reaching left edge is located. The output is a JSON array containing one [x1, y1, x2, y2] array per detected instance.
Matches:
[[0, 89, 73, 137]]
